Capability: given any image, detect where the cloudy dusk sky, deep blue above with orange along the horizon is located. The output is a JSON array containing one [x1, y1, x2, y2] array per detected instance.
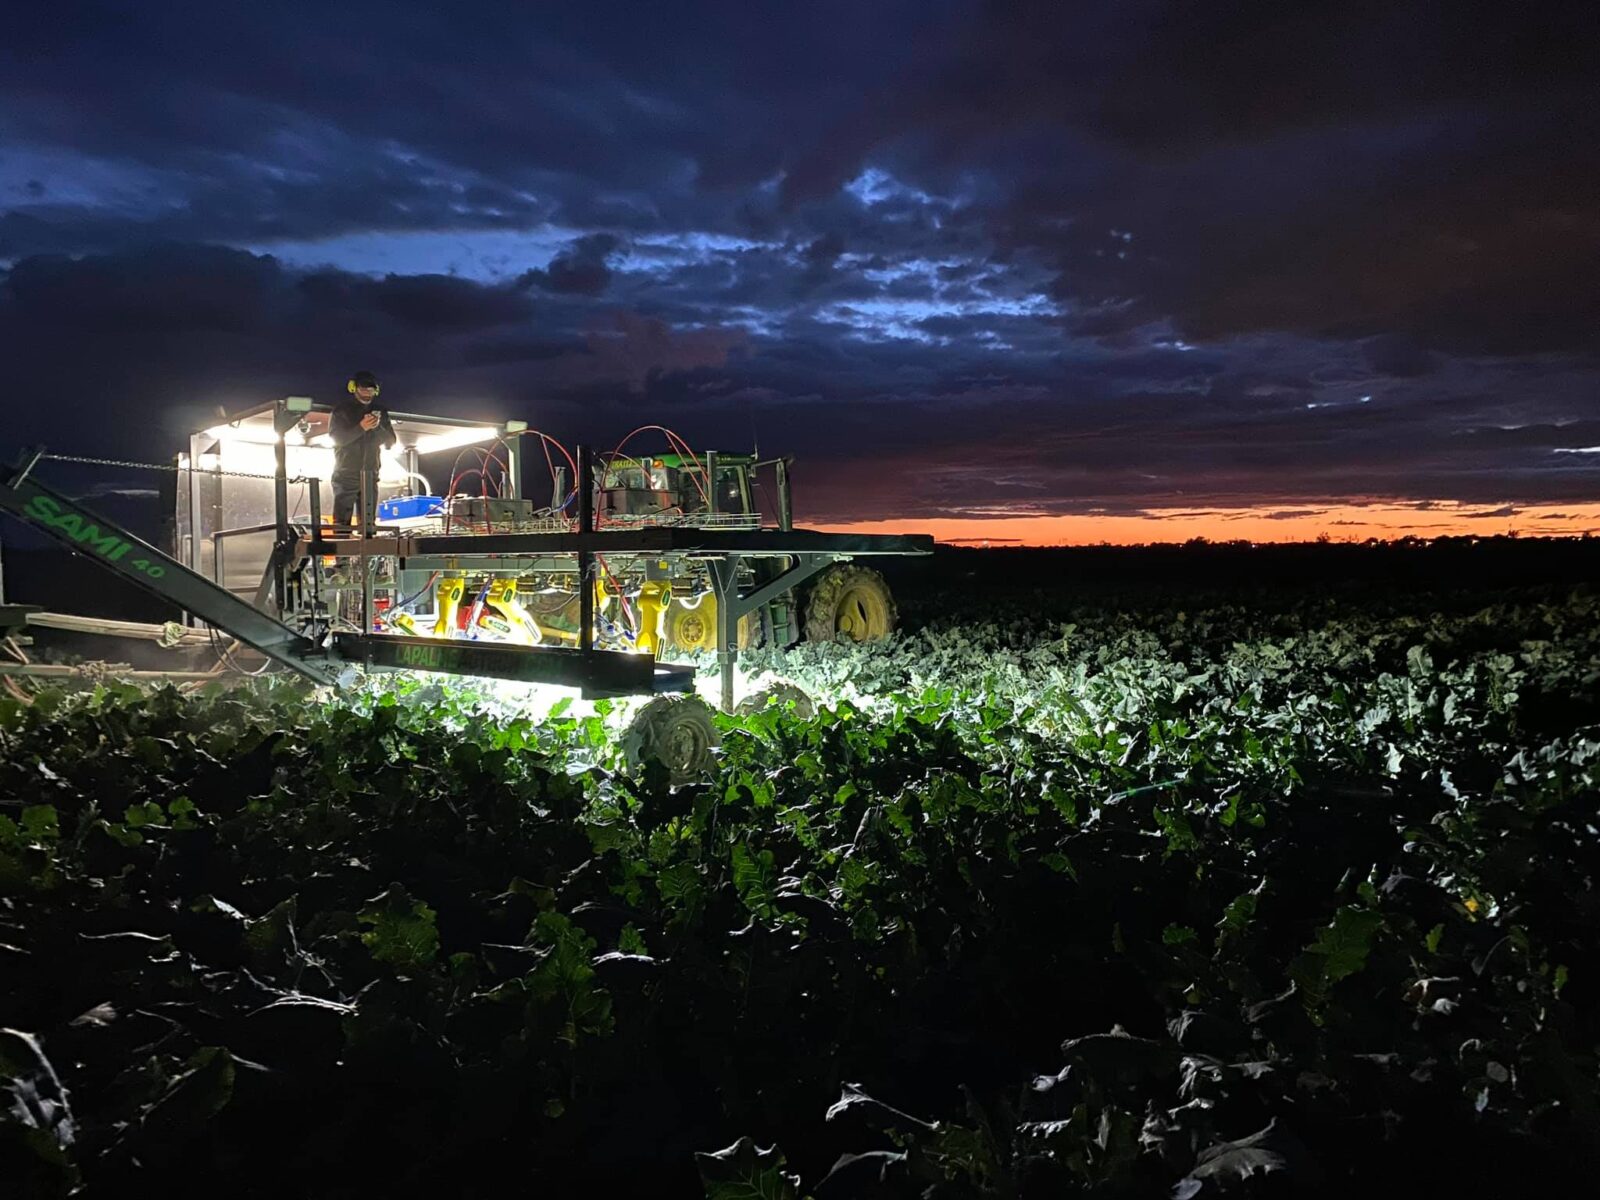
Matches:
[[0, 0, 1600, 542]]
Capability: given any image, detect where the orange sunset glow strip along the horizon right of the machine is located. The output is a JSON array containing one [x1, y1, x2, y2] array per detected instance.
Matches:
[[814, 501, 1600, 546]]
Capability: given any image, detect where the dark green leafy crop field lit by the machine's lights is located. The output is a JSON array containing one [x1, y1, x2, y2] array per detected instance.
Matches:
[[0, 569, 1600, 1200]]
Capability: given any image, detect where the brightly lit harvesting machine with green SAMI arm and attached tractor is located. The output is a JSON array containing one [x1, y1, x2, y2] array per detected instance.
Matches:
[[0, 397, 933, 780]]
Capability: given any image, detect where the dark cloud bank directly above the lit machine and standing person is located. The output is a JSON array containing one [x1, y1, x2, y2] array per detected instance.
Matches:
[[0, 246, 744, 458]]
